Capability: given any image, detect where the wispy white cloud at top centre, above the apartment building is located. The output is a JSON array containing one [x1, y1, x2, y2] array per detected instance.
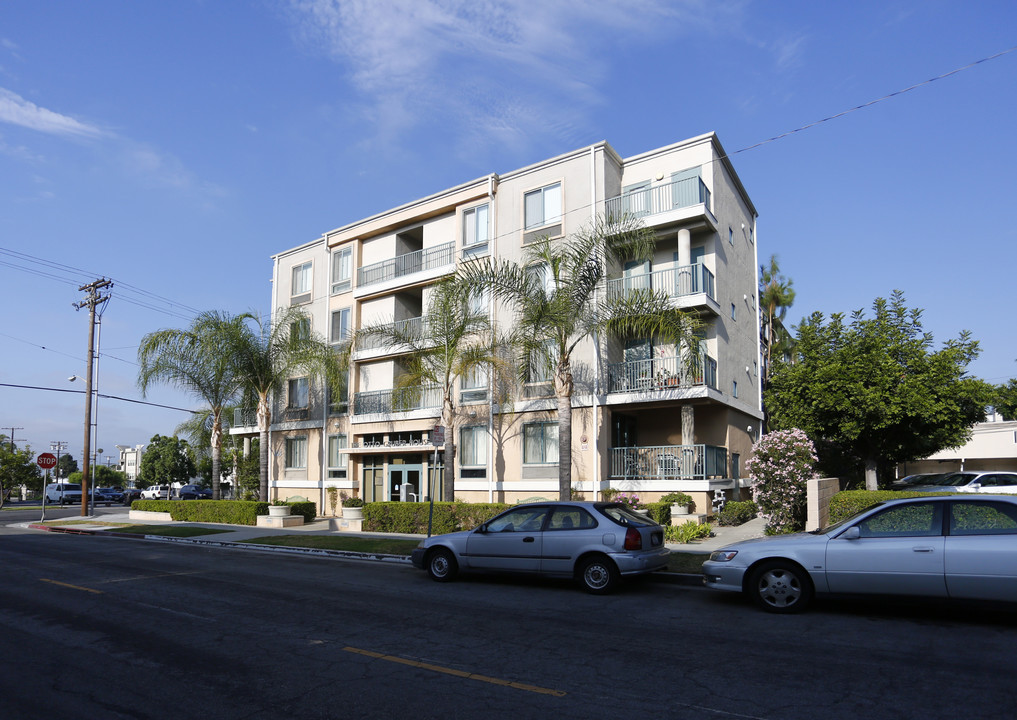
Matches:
[[289, 0, 724, 149]]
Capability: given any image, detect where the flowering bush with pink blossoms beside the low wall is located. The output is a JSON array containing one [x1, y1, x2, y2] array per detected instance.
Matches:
[[745, 429, 817, 535]]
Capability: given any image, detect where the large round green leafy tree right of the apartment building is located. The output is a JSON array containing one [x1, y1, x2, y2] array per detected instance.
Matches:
[[766, 291, 993, 489]]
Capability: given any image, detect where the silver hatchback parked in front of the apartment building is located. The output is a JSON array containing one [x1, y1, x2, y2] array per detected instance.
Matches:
[[412, 502, 670, 594]]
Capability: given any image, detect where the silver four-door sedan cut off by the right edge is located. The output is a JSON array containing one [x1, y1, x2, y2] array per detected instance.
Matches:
[[703, 495, 1017, 612]]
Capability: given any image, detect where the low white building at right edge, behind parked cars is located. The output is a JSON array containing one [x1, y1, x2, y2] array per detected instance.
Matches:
[[898, 412, 1017, 477]]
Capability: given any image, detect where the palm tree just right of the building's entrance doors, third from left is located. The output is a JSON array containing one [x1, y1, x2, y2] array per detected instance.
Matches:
[[349, 278, 502, 502]]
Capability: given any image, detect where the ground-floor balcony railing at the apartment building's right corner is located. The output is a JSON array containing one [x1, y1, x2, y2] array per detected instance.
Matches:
[[608, 445, 727, 480]]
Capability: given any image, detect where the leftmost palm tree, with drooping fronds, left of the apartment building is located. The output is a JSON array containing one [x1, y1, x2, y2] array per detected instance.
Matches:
[[137, 311, 245, 500]]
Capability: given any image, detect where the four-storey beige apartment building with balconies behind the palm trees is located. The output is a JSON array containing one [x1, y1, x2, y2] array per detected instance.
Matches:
[[231, 133, 763, 512]]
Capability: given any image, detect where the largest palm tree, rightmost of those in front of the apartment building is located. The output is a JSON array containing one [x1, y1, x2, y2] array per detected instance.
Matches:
[[460, 216, 699, 499]]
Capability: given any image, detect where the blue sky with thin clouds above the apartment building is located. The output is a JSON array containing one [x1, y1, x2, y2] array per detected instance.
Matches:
[[0, 0, 1017, 462]]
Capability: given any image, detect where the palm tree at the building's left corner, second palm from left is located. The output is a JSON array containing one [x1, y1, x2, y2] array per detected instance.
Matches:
[[231, 307, 346, 501]]
